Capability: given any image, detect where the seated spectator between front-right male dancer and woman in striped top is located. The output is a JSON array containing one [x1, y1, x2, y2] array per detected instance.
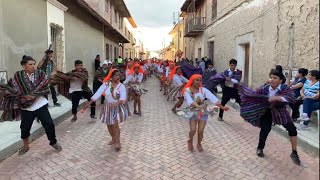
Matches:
[[289, 68, 308, 121]]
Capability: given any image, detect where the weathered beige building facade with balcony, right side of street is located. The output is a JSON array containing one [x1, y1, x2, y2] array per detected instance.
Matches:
[[181, 0, 319, 87]]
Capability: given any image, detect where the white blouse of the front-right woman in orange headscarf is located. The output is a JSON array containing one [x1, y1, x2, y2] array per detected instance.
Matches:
[[184, 87, 219, 106]]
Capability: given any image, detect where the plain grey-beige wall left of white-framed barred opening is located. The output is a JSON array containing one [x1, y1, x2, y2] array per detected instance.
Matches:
[[0, 0, 48, 77]]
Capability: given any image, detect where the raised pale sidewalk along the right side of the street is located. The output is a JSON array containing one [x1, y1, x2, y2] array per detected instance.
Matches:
[[216, 87, 319, 156]]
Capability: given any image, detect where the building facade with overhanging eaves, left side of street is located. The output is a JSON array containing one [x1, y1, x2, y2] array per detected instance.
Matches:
[[0, 0, 134, 83]]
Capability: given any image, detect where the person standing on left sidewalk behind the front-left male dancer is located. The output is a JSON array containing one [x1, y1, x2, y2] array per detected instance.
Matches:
[[38, 50, 61, 106]]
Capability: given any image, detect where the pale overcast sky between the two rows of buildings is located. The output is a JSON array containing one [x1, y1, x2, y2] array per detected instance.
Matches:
[[124, 0, 185, 50]]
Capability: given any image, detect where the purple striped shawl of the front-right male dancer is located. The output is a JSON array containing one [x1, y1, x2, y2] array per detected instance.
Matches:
[[238, 84, 295, 127]]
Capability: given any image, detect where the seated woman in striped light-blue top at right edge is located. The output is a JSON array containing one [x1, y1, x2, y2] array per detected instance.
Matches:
[[298, 70, 320, 129]]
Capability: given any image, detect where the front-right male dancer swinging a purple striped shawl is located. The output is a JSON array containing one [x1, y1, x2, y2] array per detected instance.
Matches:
[[238, 69, 301, 165]]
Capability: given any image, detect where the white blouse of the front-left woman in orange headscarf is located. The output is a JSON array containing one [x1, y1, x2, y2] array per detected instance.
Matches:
[[91, 82, 127, 103]]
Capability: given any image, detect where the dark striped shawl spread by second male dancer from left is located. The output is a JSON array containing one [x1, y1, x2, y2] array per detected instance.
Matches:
[[54, 68, 92, 99]]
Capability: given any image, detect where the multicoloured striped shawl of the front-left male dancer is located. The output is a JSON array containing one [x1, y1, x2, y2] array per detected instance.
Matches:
[[0, 70, 50, 121]]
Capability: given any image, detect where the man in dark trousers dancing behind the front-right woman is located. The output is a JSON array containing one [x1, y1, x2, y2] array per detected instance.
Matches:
[[218, 59, 242, 121]]
